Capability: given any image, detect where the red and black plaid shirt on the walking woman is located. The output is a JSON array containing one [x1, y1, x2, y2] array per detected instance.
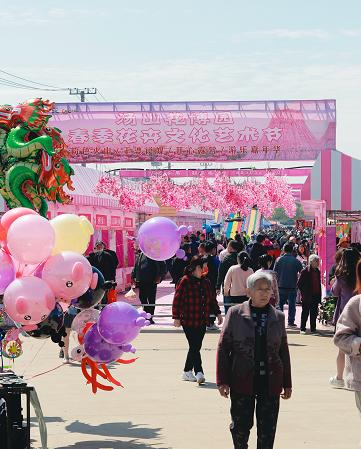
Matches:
[[172, 275, 221, 328]]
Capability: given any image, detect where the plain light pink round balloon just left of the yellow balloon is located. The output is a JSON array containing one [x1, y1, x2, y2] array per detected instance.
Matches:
[[7, 215, 55, 265]]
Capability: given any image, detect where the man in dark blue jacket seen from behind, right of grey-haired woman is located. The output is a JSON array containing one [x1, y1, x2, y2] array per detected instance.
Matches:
[[274, 243, 303, 327]]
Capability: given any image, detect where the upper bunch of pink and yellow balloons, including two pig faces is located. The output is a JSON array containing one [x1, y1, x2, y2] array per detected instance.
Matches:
[[0, 207, 94, 352]]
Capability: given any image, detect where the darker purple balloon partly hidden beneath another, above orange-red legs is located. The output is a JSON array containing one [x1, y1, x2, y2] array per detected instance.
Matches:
[[84, 324, 124, 363]]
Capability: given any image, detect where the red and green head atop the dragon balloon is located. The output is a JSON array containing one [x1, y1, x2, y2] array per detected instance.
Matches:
[[11, 98, 54, 132]]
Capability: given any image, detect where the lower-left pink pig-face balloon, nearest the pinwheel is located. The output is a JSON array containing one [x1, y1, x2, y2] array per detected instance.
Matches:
[[4, 276, 55, 326]]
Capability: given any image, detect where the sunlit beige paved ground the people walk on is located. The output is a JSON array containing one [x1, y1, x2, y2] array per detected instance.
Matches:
[[9, 284, 361, 449]]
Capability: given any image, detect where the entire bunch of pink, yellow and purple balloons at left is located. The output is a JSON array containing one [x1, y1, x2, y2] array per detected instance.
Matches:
[[0, 208, 149, 393]]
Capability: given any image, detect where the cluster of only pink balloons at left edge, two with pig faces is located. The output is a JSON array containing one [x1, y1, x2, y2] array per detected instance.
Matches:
[[0, 208, 98, 331]]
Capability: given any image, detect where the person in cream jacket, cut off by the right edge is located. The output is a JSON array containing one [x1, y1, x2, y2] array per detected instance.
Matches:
[[334, 261, 361, 416]]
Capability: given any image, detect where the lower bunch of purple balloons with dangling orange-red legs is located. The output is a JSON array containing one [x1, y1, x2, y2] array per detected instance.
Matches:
[[71, 302, 151, 393]]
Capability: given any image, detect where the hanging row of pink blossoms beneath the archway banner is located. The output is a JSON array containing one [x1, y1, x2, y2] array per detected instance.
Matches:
[[97, 172, 296, 217]]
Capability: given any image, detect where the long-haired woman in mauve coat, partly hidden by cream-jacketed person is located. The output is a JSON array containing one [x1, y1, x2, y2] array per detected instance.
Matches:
[[330, 248, 361, 388]]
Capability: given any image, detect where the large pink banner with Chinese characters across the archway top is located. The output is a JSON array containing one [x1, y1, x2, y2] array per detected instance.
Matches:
[[50, 100, 336, 163]]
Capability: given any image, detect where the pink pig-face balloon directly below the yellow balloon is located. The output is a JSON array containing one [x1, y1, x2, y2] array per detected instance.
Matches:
[[41, 251, 98, 302]]
